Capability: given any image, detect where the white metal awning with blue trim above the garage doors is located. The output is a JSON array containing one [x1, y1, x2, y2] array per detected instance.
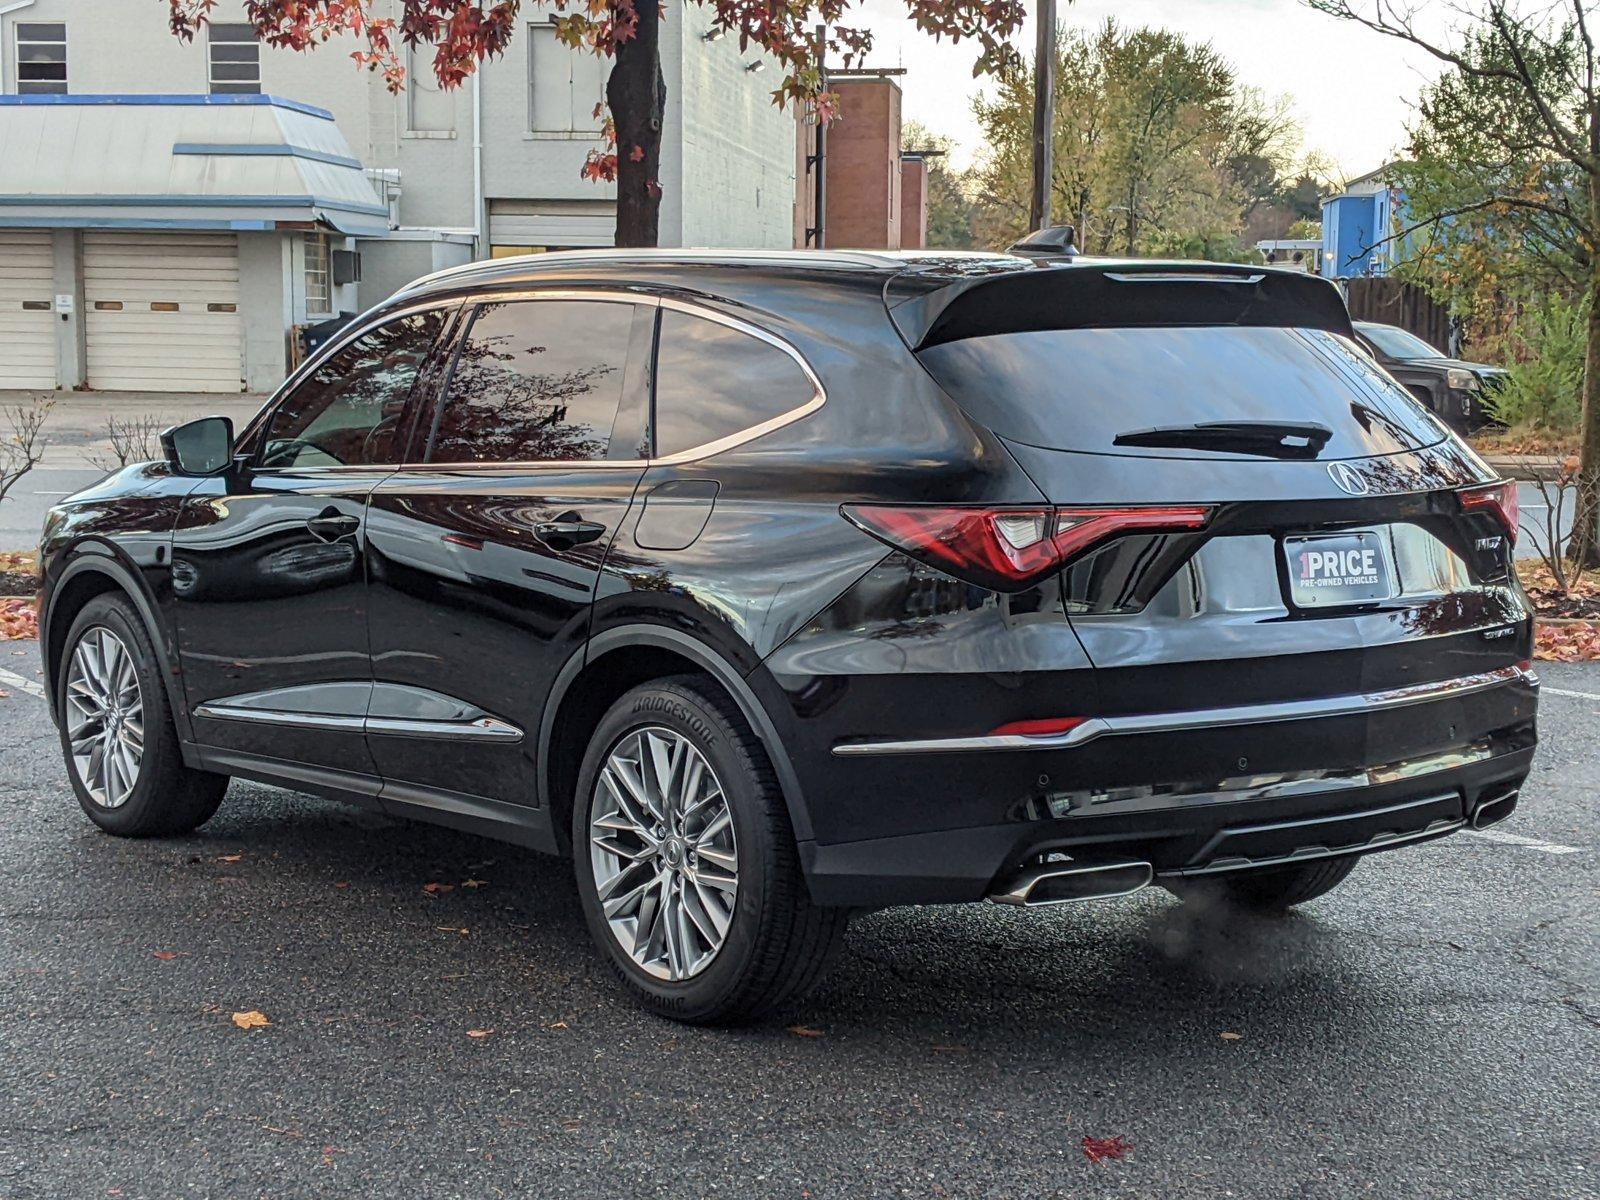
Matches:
[[0, 96, 389, 237]]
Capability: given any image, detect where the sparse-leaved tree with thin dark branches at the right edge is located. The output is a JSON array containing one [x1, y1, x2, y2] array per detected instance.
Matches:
[[1309, 0, 1600, 565]]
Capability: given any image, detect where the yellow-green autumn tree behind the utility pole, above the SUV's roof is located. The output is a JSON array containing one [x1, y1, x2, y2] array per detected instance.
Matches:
[[973, 21, 1298, 258]]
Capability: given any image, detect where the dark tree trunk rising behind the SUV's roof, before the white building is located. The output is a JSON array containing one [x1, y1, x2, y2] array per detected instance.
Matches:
[[605, 0, 667, 246]]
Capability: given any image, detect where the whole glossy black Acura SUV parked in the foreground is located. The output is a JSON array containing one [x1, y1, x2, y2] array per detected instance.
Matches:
[[43, 253, 1538, 1021]]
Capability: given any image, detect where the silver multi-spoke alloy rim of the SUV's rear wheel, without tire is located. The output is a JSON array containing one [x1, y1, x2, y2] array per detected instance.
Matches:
[[589, 726, 739, 982]]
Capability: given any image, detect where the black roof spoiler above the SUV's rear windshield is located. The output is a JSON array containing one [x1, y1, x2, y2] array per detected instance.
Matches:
[[885, 258, 1354, 350]]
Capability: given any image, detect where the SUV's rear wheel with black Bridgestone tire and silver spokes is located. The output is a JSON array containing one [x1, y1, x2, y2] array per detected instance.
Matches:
[[573, 675, 848, 1024]]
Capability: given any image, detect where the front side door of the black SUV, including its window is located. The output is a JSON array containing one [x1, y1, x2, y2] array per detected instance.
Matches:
[[171, 307, 453, 794]]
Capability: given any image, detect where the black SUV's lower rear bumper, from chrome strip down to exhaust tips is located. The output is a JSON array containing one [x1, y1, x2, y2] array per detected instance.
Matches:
[[800, 667, 1538, 907]]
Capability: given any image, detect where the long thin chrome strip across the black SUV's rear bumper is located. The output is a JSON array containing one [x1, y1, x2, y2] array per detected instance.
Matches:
[[834, 666, 1539, 758]]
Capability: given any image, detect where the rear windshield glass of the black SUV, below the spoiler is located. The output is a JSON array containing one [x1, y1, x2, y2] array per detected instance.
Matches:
[[917, 325, 1446, 459]]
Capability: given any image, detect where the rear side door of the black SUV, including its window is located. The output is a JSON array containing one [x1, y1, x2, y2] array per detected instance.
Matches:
[[366, 296, 654, 842]]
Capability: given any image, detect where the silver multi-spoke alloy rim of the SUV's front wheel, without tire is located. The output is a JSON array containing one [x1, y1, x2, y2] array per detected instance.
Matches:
[[66, 626, 144, 808]]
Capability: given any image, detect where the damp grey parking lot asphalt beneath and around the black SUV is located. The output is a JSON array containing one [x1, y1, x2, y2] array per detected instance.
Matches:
[[0, 643, 1600, 1200]]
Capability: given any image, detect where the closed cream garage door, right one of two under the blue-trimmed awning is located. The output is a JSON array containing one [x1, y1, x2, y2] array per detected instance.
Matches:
[[83, 234, 243, 392]]
